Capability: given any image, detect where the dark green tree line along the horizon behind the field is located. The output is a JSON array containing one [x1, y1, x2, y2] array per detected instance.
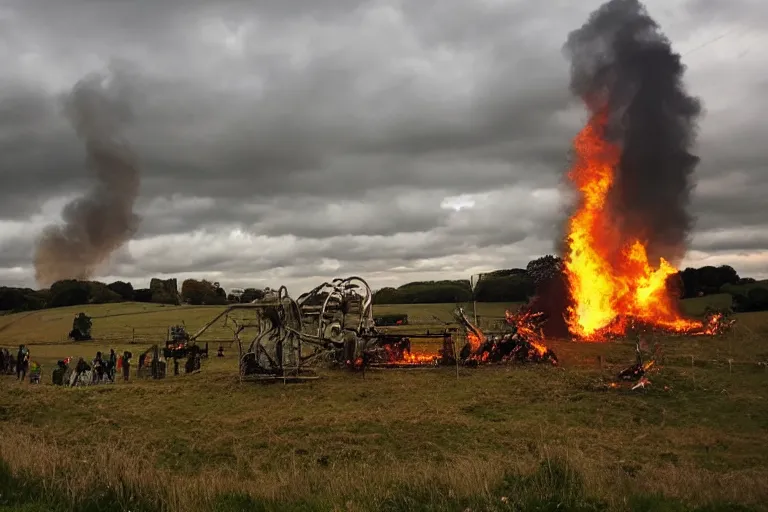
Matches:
[[0, 255, 768, 312]]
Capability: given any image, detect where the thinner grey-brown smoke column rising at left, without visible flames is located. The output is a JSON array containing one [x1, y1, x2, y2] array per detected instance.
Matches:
[[35, 76, 139, 286]]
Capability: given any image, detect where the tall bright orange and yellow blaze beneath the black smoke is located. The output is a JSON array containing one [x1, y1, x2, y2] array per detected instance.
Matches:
[[565, 114, 704, 340]]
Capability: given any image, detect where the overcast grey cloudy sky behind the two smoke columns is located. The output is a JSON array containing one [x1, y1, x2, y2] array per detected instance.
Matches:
[[0, 0, 768, 296]]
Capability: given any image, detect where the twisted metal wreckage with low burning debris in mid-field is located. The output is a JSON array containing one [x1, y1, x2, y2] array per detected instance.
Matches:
[[190, 277, 557, 381]]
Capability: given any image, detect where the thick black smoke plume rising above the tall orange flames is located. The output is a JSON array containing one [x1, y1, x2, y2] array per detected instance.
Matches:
[[564, 0, 701, 264]]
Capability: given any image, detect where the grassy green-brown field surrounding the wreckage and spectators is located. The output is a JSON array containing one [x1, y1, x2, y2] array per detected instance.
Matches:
[[0, 296, 768, 512]]
